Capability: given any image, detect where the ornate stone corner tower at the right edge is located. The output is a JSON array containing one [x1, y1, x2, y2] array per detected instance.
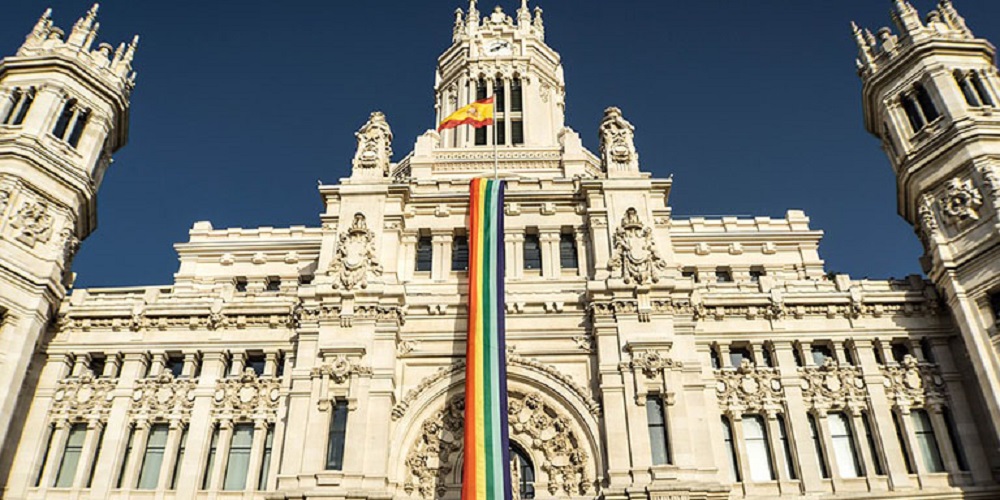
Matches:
[[853, 0, 1000, 446]]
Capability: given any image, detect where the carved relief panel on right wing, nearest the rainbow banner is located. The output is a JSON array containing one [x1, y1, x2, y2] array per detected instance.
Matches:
[[715, 359, 784, 414]]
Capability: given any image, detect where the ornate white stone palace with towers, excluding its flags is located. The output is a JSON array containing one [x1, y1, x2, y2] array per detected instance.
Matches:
[[0, 0, 1000, 499]]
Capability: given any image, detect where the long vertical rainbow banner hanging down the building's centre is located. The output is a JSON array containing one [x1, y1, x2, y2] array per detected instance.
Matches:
[[462, 179, 511, 500]]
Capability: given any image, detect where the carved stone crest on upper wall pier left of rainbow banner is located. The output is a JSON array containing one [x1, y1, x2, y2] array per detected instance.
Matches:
[[330, 212, 382, 290]]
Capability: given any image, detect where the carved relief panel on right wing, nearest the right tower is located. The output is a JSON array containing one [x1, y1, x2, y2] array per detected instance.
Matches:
[[882, 354, 946, 410]]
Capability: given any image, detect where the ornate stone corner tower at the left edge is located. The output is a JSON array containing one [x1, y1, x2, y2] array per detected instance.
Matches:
[[0, 5, 138, 452]]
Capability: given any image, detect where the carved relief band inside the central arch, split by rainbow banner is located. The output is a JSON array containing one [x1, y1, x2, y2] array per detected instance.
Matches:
[[404, 392, 591, 498]]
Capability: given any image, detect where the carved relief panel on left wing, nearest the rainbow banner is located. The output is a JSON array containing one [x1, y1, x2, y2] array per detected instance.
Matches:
[[212, 368, 281, 420]]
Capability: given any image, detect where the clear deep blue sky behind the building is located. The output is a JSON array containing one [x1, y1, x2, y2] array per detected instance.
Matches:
[[0, 0, 1000, 286]]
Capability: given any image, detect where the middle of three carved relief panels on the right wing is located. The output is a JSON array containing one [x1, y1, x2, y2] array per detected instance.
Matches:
[[799, 358, 868, 412]]
